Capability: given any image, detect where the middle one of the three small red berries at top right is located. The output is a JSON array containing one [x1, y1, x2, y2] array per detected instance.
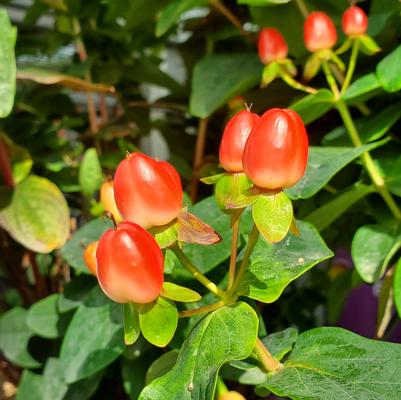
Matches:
[[304, 12, 337, 53]]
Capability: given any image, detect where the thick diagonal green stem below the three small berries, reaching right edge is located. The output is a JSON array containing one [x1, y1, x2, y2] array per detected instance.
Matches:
[[336, 99, 401, 220]]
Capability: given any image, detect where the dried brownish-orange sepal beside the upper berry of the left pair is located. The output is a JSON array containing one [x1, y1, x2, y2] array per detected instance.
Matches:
[[176, 210, 221, 245]]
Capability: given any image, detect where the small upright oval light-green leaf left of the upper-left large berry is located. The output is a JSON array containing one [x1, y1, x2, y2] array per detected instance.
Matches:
[[78, 148, 103, 197]]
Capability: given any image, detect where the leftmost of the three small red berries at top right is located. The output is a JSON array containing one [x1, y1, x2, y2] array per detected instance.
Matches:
[[258, 28, 288, 64]]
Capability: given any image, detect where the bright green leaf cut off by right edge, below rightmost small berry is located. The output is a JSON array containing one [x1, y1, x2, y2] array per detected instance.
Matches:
[[376, 45, 401, 93]]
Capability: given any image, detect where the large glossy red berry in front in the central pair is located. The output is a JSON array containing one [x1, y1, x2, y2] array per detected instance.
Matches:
[[243, 108, 308, 190]]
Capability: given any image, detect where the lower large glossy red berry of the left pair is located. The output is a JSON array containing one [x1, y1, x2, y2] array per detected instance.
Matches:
[[96, 222, 164, 303]]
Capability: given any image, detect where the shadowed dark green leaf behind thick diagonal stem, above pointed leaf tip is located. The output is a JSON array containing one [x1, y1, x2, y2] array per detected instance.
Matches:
[[323, 103, 401, 146]]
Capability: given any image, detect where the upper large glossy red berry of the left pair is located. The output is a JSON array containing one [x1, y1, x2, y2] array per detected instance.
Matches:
[[114, 153, 182, 228]]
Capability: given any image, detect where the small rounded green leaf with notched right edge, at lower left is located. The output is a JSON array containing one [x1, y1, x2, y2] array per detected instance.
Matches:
[[27, 293, 69, 339]]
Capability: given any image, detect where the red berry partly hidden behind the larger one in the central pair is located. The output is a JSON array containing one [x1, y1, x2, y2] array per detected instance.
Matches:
[[219, 110, 260, 172]]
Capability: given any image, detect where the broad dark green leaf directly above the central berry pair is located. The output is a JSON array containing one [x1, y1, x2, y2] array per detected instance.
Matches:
[[190, 53, 262, 118]]
